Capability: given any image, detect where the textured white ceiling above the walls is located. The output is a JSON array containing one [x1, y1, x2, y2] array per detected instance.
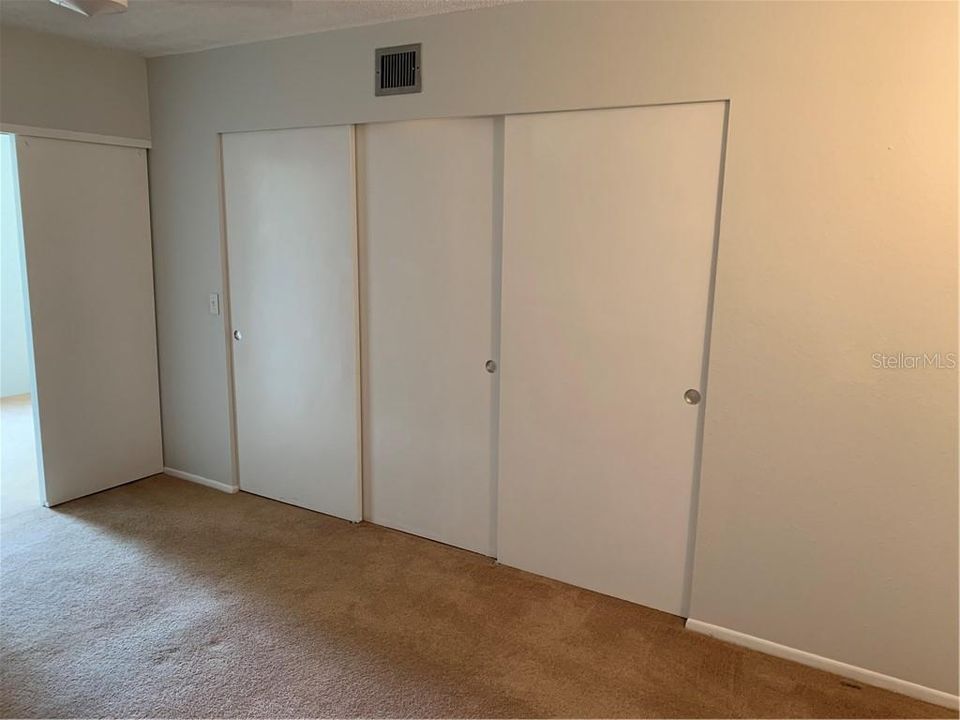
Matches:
[[0, 0, 516, 57]]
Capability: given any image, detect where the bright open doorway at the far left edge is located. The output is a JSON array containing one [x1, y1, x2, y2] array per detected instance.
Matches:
[[0, 133, 42, 518]]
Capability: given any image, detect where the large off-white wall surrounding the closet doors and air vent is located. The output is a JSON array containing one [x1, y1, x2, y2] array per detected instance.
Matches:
[[148, 2, 958, 693]]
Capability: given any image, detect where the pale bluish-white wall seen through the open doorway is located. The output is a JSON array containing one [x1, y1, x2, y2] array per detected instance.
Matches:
[[0, 135, 30, 397]]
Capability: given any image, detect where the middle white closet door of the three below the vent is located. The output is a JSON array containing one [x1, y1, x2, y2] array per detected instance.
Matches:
[[359, 119, 496, 555]]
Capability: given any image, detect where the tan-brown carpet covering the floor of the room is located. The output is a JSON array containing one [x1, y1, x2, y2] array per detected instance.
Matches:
[[0, 476, 956, 717]]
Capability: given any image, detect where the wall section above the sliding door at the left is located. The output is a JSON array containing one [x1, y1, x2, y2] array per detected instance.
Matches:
[[0, 25, 150, 140]]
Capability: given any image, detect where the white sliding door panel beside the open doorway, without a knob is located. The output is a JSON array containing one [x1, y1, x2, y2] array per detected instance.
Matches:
[[17, 137, 163, 505]]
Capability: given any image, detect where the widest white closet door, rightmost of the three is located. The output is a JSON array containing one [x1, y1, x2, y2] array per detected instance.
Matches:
[[499, 103, 724, 614]]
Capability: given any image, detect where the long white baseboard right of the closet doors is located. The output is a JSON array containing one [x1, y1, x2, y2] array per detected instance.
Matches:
[[686, 618, 960, 710]]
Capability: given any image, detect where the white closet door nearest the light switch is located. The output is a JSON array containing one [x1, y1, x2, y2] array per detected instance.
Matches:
[[223, 126, 360, 520]]
